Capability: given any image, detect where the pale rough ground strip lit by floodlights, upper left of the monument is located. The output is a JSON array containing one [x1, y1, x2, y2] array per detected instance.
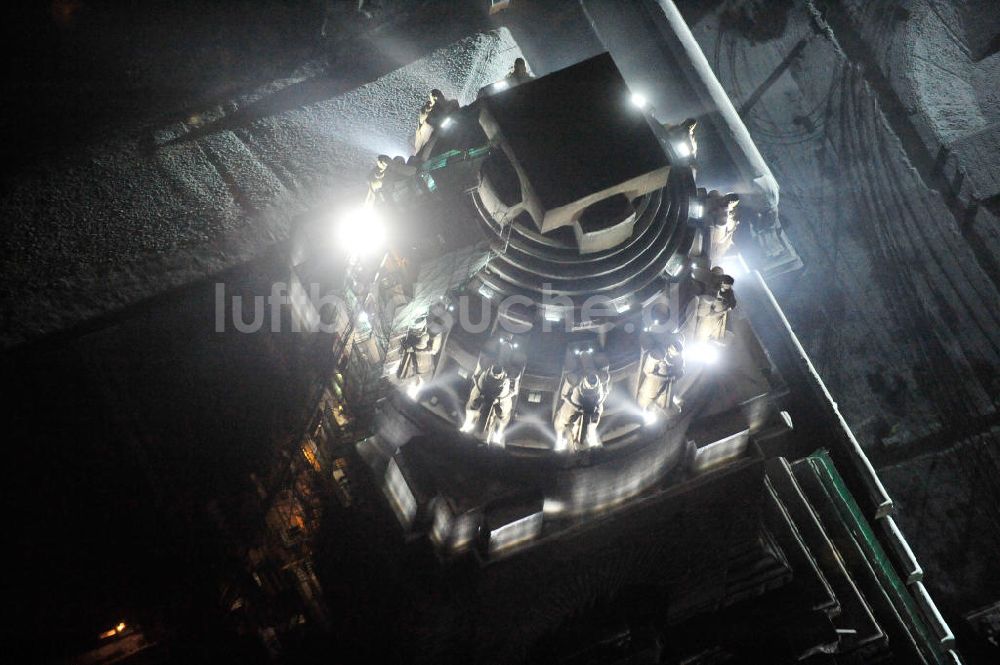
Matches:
[[0, 29, 521, 346]]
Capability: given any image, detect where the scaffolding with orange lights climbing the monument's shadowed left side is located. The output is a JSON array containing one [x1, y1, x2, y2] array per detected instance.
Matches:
[[222, 246, 400, 653]]
